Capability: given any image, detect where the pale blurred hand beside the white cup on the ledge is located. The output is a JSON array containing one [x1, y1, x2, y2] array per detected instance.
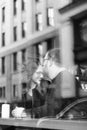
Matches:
[[12, 107, 27, 118]]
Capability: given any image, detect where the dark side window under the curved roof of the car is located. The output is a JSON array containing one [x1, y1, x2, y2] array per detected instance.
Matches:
[[62, 102, 87, 120]]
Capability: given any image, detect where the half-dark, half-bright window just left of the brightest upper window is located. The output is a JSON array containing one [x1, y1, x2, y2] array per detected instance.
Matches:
[[36, 13, 43, 31]]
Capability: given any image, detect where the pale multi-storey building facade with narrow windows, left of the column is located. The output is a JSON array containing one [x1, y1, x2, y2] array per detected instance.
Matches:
[[0, 0, 61, 102]]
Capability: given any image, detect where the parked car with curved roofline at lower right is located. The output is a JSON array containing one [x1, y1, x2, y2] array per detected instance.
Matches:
[[56, 98, 87, 120]]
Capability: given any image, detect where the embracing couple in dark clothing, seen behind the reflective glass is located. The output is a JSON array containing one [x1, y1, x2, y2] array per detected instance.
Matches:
[[12, 48, 80, 118]]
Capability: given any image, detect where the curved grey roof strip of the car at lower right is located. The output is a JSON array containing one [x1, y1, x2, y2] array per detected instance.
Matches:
[[56, 98, 87, 118]]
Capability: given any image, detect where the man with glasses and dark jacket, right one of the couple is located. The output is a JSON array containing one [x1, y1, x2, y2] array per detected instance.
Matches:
[[42, 48, 80, 117]]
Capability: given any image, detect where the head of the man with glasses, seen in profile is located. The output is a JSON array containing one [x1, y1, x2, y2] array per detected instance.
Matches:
[[43, 48, 61, 79]]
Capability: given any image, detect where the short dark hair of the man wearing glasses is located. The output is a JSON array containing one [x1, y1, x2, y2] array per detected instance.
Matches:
[[47, 48, 61, 64]]
